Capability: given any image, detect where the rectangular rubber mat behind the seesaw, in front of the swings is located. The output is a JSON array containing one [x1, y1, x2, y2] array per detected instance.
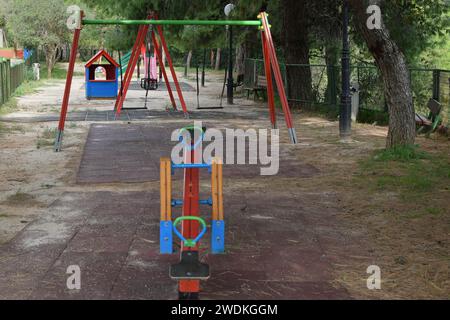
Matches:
[[77, 121, 318, 183]]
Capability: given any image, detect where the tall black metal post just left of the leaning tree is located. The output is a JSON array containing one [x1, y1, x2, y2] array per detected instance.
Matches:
[[339, 0, 352, 139]]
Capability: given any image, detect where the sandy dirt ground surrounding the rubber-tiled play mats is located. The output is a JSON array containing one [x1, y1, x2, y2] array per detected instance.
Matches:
[[0, 63, 450, 299]]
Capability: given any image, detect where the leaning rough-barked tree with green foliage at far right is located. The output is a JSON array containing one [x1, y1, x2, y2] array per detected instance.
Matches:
[[349, 0, 449, 148]]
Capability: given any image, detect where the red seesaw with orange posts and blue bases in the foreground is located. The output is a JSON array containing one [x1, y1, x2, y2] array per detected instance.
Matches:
[[160, 127, 225, 299]]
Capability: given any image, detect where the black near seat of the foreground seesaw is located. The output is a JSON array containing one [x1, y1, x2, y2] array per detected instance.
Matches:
[[170, 251, 210, 280]]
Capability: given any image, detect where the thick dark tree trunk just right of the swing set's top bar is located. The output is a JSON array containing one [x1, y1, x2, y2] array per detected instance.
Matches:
[[280, 0, 313, 107]]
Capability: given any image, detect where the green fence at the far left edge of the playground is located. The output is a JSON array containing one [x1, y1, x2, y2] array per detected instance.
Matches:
[[0, 59, 26, 106]]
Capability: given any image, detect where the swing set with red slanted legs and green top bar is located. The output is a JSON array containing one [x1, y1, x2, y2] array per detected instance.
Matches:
[[55, 11, 297, 152]]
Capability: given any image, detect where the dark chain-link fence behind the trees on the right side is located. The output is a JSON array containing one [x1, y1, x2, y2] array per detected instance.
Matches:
[[244, 59, 450, 125]]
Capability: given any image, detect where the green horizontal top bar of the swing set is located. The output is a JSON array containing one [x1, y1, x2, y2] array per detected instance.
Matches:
[[83, 19, 262, 27]]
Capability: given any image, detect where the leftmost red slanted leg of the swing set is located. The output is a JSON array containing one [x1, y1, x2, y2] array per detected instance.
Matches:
[[55, 26, 82, 152]]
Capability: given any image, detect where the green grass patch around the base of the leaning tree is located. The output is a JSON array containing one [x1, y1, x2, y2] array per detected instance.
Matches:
[[355, 146, 450, 200]]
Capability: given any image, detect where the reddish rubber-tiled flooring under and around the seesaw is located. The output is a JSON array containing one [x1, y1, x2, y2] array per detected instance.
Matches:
[[0, 125, 353, 299]]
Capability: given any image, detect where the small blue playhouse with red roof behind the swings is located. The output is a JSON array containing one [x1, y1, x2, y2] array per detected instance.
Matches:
[[85, 50, 120, 100]]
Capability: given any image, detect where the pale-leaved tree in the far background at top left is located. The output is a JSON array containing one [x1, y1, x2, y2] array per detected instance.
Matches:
[[7, 0, 69, 78]]
